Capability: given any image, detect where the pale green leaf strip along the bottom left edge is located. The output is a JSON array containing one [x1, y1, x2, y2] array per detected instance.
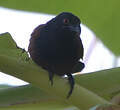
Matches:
[[0, 100, 80, 110]]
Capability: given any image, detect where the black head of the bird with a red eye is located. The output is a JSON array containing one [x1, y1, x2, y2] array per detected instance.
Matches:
[[48, 12, 81, 34]]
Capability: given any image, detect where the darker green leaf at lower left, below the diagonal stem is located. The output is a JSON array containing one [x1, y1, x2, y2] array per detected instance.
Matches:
[[0, 84, 60, 106]]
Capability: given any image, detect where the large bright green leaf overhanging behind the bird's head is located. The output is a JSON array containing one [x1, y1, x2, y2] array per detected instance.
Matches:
[[0, 0, 120, 55]]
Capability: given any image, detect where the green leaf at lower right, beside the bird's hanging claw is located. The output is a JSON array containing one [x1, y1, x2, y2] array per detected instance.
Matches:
[[75, 68, 120, 101]]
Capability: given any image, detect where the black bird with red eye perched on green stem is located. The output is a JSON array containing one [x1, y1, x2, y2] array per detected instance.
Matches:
[[28, 12, 85, 98]]
